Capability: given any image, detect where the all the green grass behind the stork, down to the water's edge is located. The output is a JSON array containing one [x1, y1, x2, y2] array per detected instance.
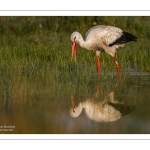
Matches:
[[0, 16, 150, 88]]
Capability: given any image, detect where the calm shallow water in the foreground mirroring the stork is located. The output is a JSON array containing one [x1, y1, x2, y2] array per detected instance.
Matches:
[[0, 67, 150, 134]]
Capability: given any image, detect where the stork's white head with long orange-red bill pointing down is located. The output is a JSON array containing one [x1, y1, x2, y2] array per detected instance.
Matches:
[[70, 31, 81, 61]]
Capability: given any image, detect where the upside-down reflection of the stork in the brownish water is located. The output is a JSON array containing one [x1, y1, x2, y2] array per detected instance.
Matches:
[[69, 81, 135, 122]]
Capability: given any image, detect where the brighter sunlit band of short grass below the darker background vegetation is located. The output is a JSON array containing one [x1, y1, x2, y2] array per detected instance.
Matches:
[[0, 30, 150, 87]]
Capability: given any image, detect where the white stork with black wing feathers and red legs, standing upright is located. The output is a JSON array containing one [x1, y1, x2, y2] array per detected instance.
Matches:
[[70, 25, 137, 76]]
